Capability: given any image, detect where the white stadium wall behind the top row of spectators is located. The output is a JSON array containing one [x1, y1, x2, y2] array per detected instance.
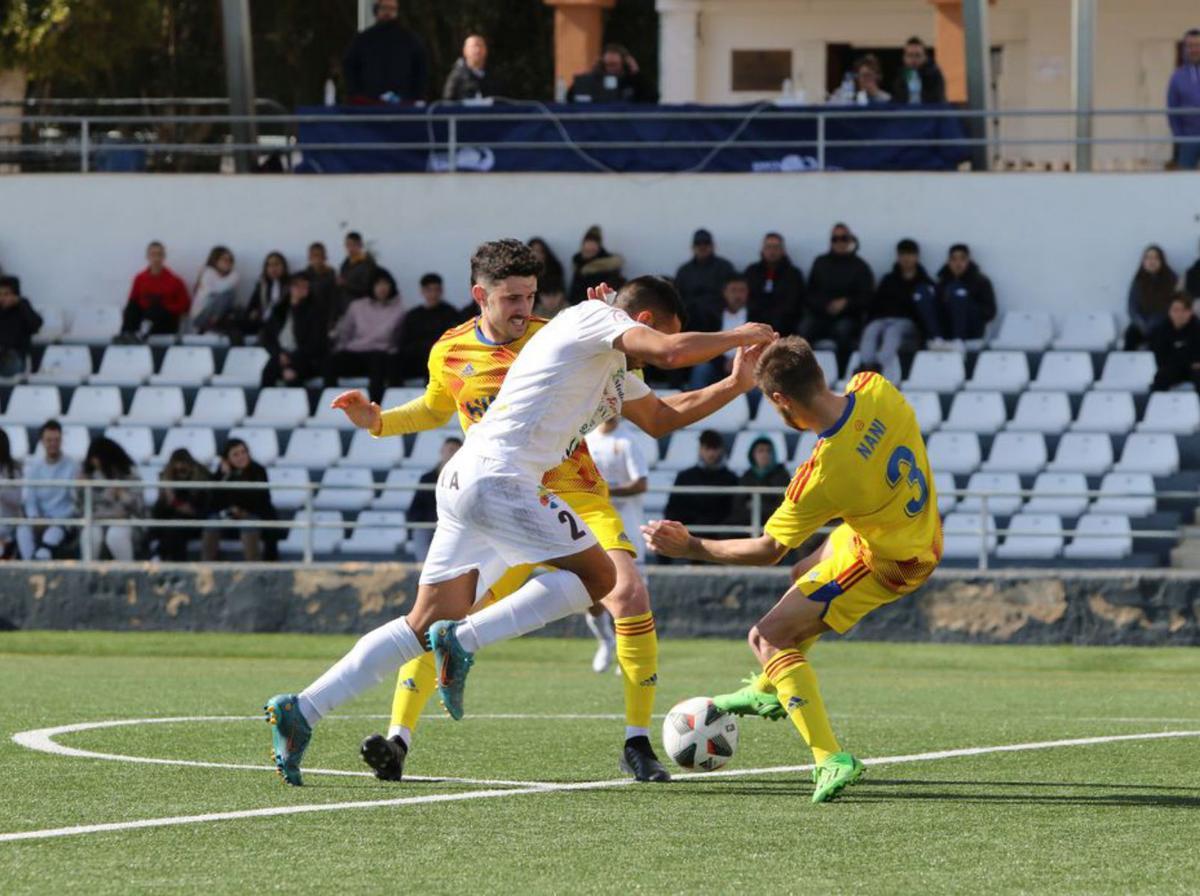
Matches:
[[0, 173, 1200, 312]]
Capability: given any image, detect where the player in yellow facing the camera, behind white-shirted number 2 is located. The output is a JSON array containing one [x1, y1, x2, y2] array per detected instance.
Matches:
[[334, 243, 772, 781]]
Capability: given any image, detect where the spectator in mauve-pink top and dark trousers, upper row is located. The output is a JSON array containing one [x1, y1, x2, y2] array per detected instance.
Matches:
[[325, 267, 404, 402]]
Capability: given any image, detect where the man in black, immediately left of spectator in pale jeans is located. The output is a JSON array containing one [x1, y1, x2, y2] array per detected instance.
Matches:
[[799, 223, 875, 367]]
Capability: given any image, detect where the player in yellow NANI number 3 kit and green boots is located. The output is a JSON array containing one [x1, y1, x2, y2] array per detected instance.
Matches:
[[642, 337, 942, 802]]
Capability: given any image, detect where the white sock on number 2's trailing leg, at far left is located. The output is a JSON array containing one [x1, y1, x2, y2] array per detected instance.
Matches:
[[300, 617, 425, 724]]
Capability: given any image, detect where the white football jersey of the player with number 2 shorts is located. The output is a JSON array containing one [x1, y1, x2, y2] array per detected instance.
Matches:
[[462, 300, 650, 476]]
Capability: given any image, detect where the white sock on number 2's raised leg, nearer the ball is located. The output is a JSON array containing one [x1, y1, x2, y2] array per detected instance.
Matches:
[[455, 570, 592, 654]]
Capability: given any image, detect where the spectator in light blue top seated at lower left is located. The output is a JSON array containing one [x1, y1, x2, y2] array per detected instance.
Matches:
[[17, 420, 79, 560]]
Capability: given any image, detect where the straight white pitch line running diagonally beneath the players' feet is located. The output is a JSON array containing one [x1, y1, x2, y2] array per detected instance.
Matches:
[[0, 730, 1200, 843]]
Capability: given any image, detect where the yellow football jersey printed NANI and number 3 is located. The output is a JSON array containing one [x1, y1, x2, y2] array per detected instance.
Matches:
[[766, 373, 942, 591]]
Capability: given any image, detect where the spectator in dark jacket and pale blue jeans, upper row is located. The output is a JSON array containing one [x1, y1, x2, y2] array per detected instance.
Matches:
[[858, 239, 935, 383]]
